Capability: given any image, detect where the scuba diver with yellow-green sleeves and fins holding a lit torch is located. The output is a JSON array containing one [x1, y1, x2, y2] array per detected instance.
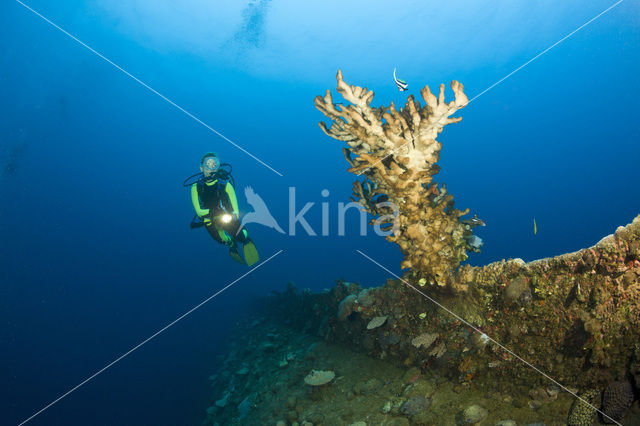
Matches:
[[184, 152, 260, 266]]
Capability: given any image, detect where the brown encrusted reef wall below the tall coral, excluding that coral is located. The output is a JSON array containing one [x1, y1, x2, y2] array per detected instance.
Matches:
[[268, 216, 640, 391]]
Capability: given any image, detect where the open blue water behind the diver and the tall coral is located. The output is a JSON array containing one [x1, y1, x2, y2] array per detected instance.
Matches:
[[0, 0, 640, 425]]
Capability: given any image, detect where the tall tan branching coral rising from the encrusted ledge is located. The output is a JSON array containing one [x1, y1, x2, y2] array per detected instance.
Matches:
[[315, 71, 478, 286]]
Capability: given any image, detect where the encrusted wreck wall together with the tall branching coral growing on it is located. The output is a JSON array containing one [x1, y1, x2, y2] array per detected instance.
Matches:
[[264, 72, 640, 422]]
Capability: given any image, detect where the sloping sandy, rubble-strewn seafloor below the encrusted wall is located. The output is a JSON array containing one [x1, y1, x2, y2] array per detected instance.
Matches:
[[203, 312, 640, 426]]
